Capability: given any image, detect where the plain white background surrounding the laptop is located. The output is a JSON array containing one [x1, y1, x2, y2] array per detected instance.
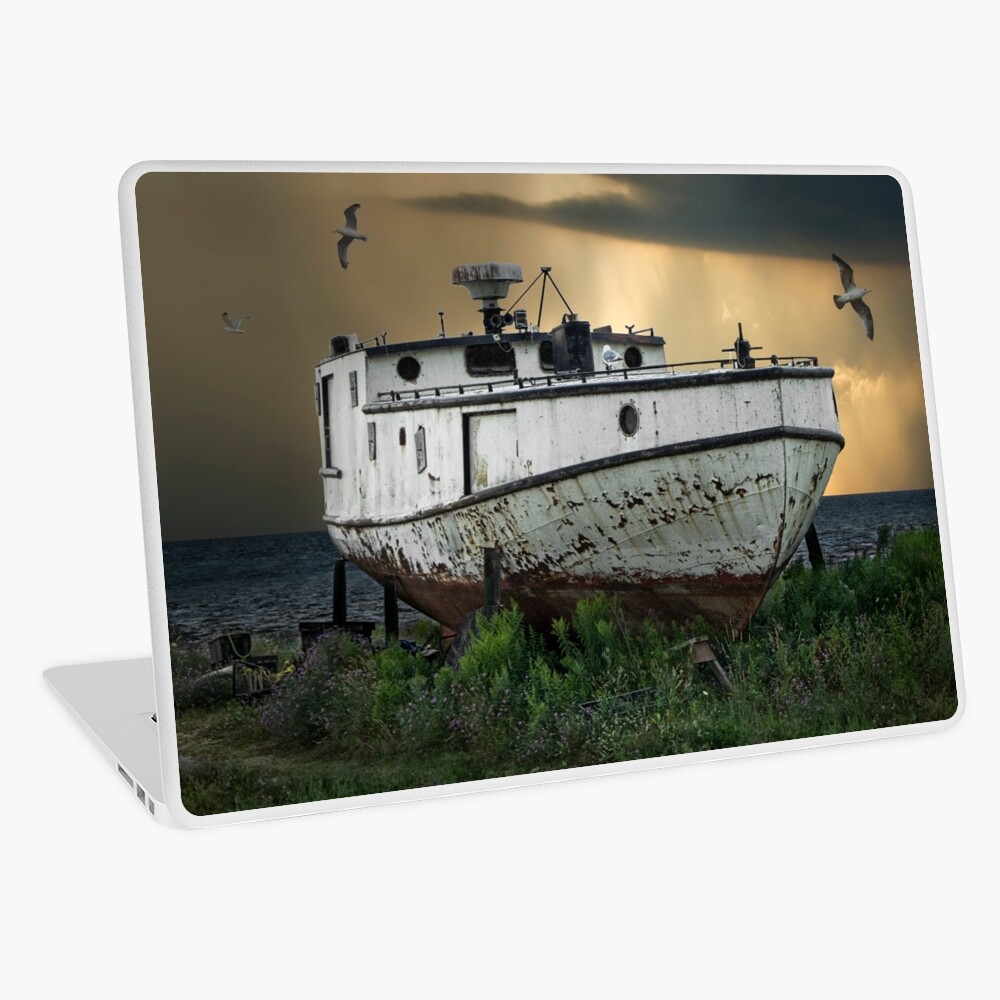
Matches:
[[0, 0, 1000, 998]]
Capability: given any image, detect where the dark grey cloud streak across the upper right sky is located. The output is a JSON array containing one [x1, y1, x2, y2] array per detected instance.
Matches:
[[408, 174, 909, 265]]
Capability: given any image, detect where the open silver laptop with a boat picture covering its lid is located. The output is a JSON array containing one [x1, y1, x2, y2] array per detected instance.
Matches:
[[45, 162, 964, 827]]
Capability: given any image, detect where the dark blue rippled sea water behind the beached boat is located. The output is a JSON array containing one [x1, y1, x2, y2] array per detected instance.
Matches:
[[163, 490, 937, 641]]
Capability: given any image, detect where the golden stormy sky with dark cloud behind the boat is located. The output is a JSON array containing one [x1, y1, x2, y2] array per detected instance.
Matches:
[[136, 171, 932, 540]]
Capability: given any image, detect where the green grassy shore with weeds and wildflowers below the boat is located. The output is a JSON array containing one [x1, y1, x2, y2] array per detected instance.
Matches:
[[174, 530, 957, 814]]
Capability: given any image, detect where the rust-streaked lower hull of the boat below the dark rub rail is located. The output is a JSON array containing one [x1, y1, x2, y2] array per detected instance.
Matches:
[[326, 426, 843, 629]]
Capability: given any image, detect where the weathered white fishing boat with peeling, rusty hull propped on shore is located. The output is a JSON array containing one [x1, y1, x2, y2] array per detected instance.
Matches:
[[316, 262, 844, 629]]
